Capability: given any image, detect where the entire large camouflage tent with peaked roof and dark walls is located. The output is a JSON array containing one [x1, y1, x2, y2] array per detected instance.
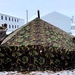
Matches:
[[0, 18, 75, 71]]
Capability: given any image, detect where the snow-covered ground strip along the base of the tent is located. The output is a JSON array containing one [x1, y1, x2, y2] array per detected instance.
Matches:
[[0, 69, 75, 75]]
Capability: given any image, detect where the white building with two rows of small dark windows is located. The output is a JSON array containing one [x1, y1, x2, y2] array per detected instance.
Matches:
[[0, 13, 25, 34]]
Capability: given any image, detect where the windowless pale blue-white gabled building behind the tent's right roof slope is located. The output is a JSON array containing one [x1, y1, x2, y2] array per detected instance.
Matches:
[[41, 11, 71, 33]]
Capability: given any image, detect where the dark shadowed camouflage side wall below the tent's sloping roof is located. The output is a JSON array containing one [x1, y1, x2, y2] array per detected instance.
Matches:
[[0, 45, 75, 71]]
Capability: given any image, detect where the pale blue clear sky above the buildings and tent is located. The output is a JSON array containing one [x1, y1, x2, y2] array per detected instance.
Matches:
[[0, 0, 75, 21]]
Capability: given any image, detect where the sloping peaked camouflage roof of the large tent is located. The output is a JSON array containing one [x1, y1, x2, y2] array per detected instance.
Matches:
[[2, 18, 75, 49]]
